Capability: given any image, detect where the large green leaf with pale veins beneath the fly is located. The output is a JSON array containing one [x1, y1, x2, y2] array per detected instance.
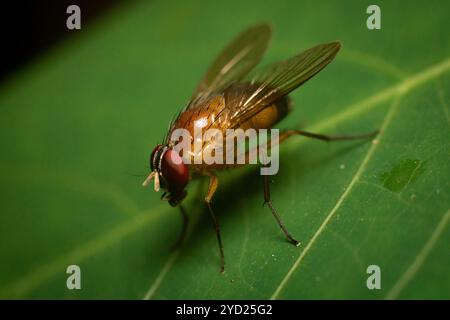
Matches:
[[0, 1, 450, 299]]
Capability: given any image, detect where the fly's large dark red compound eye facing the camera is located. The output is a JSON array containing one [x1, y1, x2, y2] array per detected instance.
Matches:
[[161, 149, 189, 192]]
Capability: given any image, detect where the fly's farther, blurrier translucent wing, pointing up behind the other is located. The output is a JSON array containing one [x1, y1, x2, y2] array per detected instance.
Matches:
[[188, 23, 271, 104]]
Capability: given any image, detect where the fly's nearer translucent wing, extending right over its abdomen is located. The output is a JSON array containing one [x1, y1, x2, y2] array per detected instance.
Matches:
[[230, 42, 341, 128]]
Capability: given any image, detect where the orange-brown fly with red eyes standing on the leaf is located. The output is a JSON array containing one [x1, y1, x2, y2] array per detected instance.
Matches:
[[143, 23, 376, 272]]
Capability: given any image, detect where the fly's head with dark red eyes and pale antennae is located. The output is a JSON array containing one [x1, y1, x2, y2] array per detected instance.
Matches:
[[142, 144, 189, 207]]
